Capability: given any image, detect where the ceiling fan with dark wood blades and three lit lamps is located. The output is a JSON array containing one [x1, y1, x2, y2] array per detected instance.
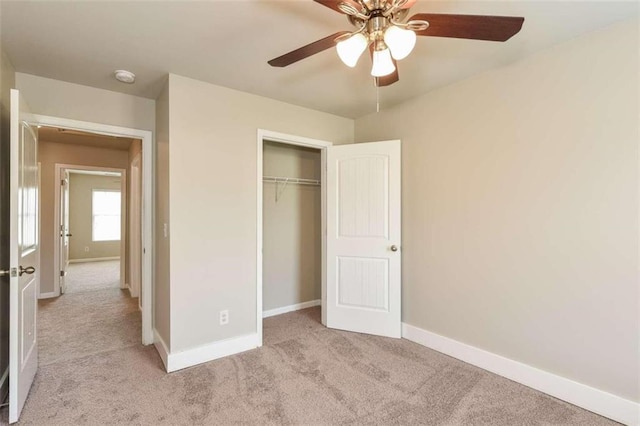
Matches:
[[268, 0, 524, 86]]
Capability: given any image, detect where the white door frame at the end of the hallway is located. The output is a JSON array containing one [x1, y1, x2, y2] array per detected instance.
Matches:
[[53, 163, 129, 298]]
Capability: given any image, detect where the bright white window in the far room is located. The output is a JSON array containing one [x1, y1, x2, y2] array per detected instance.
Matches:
[[92, 189, 121, 241]]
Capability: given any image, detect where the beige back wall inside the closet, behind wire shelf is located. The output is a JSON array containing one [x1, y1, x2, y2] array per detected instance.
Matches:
[[262, 142, 322, 311]]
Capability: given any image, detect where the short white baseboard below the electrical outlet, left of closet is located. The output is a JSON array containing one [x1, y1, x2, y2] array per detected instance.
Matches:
[[166, 333, 258, 373]]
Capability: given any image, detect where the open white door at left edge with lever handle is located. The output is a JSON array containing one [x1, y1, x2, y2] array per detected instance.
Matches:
[[9, 90, 40, 423]]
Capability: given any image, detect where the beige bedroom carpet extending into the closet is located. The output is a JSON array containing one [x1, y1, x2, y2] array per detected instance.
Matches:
[[4, 308, 615, 426]]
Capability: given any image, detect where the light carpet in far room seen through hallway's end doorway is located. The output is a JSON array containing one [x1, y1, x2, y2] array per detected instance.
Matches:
[[65, 260, 120, 294]]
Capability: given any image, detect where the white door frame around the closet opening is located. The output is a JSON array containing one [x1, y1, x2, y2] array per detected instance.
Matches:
[[256, 129, 333, 347]]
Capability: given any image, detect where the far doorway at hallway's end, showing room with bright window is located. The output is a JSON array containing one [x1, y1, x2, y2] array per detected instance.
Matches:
[[55, 166, 125, 297]]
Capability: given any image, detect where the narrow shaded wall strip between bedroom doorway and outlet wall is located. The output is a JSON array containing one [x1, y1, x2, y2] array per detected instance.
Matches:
[[153, 82, 172, 350]]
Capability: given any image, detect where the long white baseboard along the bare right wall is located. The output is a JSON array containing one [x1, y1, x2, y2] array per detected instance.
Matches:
[[402, 323, 640, 425]]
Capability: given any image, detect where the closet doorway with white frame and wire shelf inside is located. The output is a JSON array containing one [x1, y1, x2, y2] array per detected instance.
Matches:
[[257, 130, 331, 345]]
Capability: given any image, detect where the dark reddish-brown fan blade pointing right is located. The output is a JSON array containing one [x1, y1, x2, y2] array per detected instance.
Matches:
[[409, 13, 524, 41]]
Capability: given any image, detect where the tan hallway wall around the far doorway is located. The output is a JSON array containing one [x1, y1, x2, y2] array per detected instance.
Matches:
[[38, 141, 129, 293]]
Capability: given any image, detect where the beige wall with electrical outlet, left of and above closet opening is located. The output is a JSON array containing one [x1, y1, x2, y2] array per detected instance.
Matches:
[[165, 74, 353, 352]]
